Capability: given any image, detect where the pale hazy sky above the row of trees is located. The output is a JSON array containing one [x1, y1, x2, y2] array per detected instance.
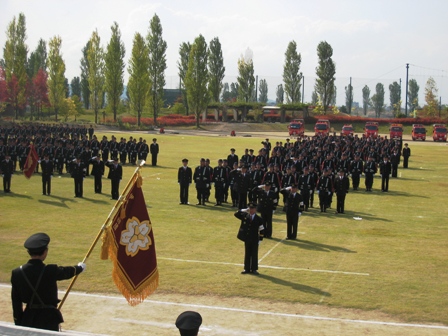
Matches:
[[0, 0, 448, 105]]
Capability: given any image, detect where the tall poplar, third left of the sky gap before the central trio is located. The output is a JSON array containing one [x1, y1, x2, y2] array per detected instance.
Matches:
[[104, 22, 126, 122]]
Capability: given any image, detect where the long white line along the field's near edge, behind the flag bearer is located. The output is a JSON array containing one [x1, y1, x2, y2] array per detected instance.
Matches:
[[0, 284, 448, 330]]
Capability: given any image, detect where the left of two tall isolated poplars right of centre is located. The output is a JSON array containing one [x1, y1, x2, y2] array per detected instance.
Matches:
[[283, 41, 302, 104]]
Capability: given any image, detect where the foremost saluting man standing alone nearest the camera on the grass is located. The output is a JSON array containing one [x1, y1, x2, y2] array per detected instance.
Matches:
[[234, 203, 264, 275]]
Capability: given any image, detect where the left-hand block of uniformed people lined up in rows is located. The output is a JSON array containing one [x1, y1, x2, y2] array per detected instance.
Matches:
[[0, 125, 159, 200]]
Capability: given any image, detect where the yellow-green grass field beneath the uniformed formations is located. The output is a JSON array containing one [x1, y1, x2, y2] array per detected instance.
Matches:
[[0, 130, 448, 325]]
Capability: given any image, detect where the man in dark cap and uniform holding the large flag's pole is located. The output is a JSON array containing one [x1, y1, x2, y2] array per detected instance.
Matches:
[[11, 233, 86, 331]]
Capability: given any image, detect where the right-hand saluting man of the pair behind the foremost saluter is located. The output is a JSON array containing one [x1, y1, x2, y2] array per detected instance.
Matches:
[[280, 184, 304, 239]]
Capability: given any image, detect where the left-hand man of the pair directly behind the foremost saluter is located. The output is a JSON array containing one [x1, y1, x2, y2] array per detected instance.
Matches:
[[254, 181, 278, 238]]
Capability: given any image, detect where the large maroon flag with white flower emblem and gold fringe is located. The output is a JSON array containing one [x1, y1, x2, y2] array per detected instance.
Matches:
[[101, 173, 159, 306]]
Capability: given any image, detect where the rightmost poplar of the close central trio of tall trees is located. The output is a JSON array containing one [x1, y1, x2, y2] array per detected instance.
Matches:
[[208, 37, 226, 102]]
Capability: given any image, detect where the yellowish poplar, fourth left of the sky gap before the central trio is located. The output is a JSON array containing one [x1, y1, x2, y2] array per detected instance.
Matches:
[[87, 30, 104, 124]]
